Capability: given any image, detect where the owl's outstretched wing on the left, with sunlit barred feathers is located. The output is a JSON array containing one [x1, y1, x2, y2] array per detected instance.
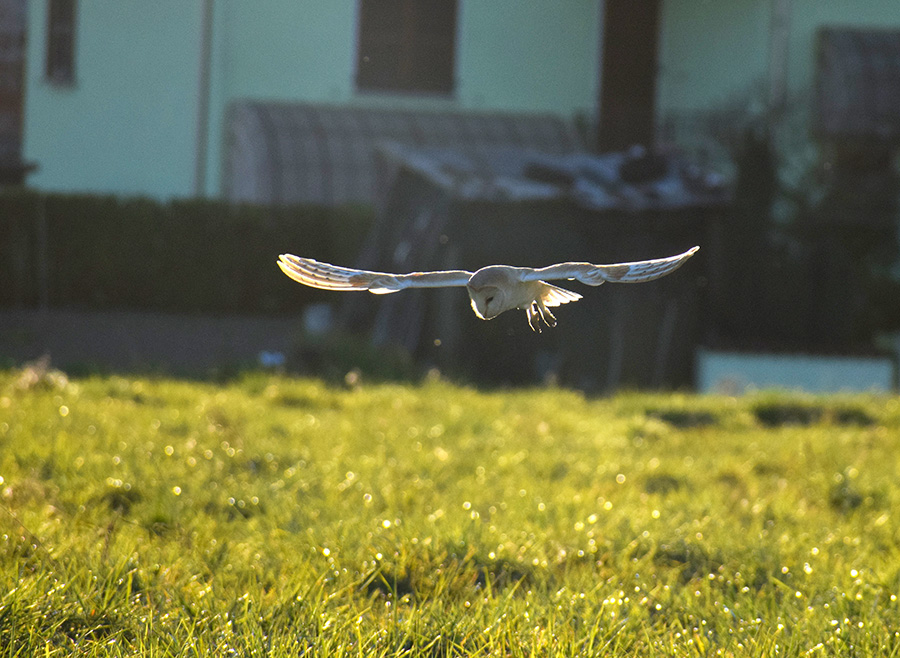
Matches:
[[278, 254, 472, 295]]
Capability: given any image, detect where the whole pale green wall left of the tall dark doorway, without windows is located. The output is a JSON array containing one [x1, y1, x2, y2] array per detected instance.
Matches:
[[25, 0, 601, 198]]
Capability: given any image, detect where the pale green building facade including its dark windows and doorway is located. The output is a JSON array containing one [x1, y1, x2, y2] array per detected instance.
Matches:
[[17, 0, 900, 199]]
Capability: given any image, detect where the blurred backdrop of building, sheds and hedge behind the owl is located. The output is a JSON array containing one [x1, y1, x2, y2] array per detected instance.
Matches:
[[0, 0, 900, 393]]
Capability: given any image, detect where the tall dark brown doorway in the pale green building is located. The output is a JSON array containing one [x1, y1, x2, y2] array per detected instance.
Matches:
[[597, 0, 660, 151]]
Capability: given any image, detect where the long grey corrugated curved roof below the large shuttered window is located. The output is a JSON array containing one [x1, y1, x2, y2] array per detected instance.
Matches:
[[224, 101, 583, 205]]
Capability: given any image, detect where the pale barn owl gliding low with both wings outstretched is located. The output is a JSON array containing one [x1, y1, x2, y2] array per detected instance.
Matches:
[[278, 247, 700, 331]]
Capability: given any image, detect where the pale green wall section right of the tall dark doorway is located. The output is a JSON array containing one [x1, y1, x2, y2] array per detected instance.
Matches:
[[656, 0, 900, 179]]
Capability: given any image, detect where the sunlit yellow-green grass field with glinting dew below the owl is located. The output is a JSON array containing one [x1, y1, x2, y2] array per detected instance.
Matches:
[[0, 371, 900, 658]]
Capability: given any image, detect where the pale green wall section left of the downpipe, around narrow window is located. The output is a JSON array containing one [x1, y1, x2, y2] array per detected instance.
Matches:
[[24, 0, 206, 197]]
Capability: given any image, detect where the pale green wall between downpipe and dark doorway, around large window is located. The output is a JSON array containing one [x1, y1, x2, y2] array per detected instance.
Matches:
[[218, 0, 600, 114]]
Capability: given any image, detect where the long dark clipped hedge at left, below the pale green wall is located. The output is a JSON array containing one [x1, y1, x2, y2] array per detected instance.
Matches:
[[0, 190, 373, 314]]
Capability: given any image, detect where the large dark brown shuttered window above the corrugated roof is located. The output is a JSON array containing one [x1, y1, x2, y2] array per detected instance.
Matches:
[[356, 0, 456, 94]]
